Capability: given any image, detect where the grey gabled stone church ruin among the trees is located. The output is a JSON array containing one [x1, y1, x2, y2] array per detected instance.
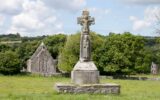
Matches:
[[27, 42, 57, 76]]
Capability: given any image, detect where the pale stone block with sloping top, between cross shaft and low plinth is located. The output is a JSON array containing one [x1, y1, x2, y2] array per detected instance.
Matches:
[[71, 61, 99, 84]]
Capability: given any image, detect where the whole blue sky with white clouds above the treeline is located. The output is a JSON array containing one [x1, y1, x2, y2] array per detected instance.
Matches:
[[0, 0, 160, 36]]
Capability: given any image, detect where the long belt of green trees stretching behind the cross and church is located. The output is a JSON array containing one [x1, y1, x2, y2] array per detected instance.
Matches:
[[0, 32, 160, 74]]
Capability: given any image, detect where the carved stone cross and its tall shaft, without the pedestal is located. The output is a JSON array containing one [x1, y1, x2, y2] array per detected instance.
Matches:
[[77, 10, 95, 62]]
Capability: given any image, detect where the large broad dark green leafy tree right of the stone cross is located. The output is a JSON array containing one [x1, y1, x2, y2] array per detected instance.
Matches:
[[93, 33, 151, 74]]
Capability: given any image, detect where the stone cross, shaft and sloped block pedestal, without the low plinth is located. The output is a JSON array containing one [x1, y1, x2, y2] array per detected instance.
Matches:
[[71, 10, 99, 84]]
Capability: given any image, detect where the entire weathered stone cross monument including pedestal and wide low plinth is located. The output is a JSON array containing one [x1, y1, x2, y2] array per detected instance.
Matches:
[[55, 10, 120, 94]]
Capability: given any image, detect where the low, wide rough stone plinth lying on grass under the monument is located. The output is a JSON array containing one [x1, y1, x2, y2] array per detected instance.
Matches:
[[55, 83, 120, 94]]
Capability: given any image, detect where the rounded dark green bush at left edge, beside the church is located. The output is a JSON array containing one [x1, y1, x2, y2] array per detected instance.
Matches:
[[0, 51, 21, 74]]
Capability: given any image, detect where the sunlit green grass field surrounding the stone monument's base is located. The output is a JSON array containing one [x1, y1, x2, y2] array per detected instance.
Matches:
[[0, 76, 160, 100]]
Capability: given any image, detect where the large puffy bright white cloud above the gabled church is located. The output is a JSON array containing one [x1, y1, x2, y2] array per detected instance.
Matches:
[[8, 0, 62, 36]]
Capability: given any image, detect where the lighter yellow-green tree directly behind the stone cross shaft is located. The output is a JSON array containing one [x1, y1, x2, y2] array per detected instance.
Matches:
[[58, 32, 103, 72]]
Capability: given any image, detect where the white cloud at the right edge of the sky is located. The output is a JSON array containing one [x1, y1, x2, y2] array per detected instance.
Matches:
[[129, 7, 160, 31]]
